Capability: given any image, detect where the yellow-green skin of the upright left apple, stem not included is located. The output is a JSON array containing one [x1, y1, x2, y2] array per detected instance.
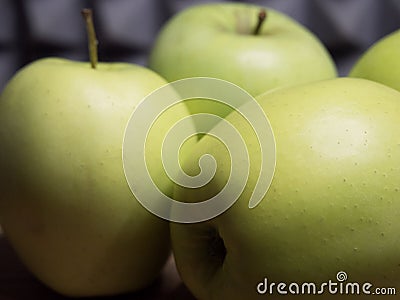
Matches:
[[0, 58, 193, 297]]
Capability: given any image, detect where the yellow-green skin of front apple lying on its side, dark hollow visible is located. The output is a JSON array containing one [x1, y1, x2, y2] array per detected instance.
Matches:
[[171, 78, 400, 300]]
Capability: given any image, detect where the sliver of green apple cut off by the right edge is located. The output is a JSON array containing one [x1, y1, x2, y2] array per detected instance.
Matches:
[[349, 30, 400, 91]]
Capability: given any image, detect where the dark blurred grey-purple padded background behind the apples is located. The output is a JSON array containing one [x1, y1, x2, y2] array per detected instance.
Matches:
[[0, 0, 400, 91]]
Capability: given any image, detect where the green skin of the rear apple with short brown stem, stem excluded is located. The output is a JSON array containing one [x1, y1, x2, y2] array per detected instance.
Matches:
[[149, 3, 337, 103]]
